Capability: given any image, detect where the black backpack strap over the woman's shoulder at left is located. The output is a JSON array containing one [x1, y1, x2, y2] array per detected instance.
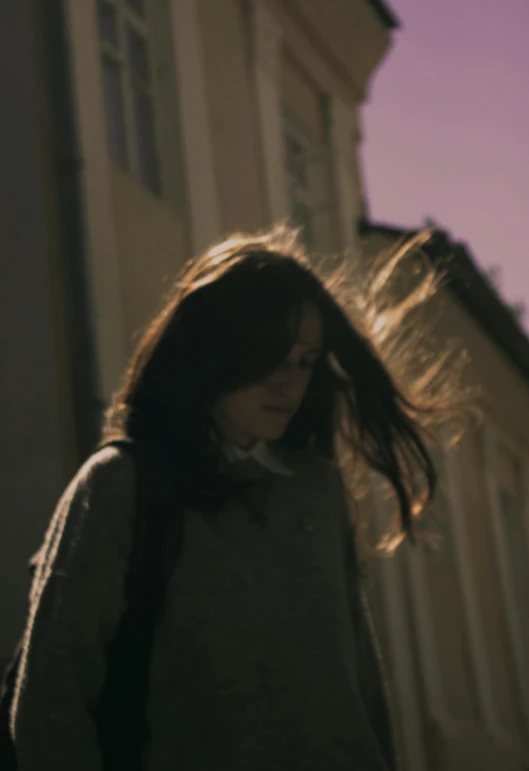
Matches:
[[96, 440, 183, 771]]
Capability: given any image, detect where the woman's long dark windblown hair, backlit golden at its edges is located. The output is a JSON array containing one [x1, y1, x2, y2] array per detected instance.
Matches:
[[101, 225, 474, 549]]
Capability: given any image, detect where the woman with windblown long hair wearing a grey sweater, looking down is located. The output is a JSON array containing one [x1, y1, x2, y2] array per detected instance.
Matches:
[[8, 228, 462, 771]]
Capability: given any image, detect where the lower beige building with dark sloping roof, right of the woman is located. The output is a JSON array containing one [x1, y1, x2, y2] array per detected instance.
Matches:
[[361, 222, 529, 771]]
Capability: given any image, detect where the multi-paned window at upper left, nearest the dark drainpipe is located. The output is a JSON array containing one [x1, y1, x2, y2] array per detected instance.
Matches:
[[97, 0, 162, 194]]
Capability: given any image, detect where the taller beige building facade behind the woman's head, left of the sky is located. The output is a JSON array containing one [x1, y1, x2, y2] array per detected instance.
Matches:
[[0, 0, 395, 658]]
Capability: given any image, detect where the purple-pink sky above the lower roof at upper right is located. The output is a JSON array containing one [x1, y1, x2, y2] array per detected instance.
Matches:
[[363, 0, 529, 322]]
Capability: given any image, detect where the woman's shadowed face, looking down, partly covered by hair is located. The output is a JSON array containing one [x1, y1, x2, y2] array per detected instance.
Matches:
[[213, 302, 323, 449]]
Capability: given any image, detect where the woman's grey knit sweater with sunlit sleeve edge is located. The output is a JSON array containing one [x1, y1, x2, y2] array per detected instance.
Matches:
[[12, 449, 395, 771]]
